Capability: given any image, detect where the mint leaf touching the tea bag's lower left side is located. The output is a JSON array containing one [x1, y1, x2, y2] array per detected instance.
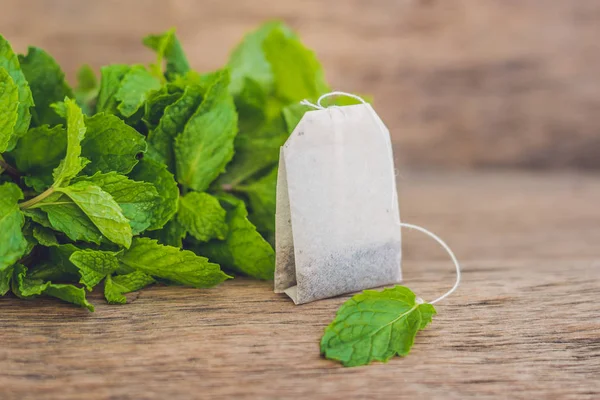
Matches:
[[195, 196, 275, 279]]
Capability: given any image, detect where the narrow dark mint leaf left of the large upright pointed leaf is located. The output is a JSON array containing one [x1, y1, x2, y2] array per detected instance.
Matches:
[[148, 85, 204, 170]]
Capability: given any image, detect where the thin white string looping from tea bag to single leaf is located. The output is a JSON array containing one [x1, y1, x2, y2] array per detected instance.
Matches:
[[300, 91, 460, 304]]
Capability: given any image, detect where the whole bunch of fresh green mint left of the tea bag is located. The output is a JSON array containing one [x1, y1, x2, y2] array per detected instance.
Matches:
[[0, 22, 358, 311]]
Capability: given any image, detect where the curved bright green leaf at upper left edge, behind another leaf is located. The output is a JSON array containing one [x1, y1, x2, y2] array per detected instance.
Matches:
[[0, 35, 34, 153]]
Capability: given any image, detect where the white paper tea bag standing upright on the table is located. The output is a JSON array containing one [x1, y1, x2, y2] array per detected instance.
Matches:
[[275, 100, 402, 304]]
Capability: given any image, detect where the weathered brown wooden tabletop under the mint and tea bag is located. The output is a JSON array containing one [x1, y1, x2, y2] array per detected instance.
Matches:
[[0, 172, 600, 400]]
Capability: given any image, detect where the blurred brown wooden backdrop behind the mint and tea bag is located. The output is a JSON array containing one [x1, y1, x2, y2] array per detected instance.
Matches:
[[0, 0, 600, 169]]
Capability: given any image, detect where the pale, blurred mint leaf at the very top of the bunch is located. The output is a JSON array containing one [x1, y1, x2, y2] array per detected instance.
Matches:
[[227, 21, 295, 94]]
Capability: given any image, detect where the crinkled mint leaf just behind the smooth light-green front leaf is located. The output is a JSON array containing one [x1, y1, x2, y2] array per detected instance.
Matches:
[[77, 172, 162, 235]]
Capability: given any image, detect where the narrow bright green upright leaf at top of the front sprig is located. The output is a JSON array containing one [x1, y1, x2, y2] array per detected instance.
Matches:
[[53, 99, 87, 187]]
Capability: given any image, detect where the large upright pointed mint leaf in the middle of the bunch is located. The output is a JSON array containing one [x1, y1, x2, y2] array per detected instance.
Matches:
[[175, 70, 237, 192]]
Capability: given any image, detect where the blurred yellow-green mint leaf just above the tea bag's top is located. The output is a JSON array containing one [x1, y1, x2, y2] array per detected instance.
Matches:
[[263, 30, 329, 103]]
